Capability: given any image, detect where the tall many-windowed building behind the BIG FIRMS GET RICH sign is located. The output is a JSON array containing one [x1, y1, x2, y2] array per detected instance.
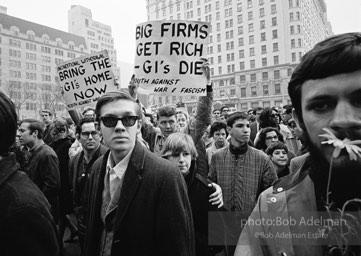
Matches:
[[147, 0, 332, 111]]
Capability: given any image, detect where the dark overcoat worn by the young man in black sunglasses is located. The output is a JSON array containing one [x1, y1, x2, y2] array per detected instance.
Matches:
[[84, 142, 194, 256]]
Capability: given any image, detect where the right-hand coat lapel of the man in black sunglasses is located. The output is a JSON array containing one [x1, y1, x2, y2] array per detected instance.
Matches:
[[114, 142, 146, 233]]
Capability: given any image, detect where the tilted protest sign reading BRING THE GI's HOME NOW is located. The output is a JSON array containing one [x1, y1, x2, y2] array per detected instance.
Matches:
[[57, 51, 117, 110]]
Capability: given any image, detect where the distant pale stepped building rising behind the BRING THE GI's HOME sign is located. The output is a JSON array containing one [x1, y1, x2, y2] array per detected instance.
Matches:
[[68, 5, 120, 79]]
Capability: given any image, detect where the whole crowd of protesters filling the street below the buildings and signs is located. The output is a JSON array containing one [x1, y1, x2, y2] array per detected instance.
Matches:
[[0, 33, 361, 256]]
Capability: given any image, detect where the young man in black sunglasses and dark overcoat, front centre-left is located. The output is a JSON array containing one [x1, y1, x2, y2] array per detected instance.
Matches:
[[84, 92, 194, 256]]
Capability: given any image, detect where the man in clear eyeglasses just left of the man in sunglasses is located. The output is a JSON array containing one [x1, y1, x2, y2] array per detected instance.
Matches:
[[69, 117, 107, 250]]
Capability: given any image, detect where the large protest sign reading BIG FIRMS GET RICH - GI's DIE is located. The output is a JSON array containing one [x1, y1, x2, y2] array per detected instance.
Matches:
[[133, 20, 210, 95]]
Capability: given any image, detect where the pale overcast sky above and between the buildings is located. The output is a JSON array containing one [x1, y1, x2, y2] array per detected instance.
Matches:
[[0, 0, 361, 63]]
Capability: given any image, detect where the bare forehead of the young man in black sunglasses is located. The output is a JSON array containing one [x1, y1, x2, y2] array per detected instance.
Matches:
[[99, 99, 138, 116]]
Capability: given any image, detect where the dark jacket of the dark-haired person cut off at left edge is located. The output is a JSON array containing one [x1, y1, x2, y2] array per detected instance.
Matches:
[[0, 154, 59, 256]]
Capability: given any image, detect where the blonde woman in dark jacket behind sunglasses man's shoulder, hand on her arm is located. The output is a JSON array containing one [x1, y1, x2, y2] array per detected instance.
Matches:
[[162, 133, 224, 256]]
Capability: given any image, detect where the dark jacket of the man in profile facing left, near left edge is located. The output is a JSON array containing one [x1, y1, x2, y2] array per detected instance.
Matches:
[[29, 144, 60, 219]]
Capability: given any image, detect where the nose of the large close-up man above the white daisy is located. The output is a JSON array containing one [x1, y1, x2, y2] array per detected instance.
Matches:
[[330, 101, 361, 131]]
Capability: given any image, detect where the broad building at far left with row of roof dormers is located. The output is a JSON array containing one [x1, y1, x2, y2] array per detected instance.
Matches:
[[0, 8, 89, 119]]
